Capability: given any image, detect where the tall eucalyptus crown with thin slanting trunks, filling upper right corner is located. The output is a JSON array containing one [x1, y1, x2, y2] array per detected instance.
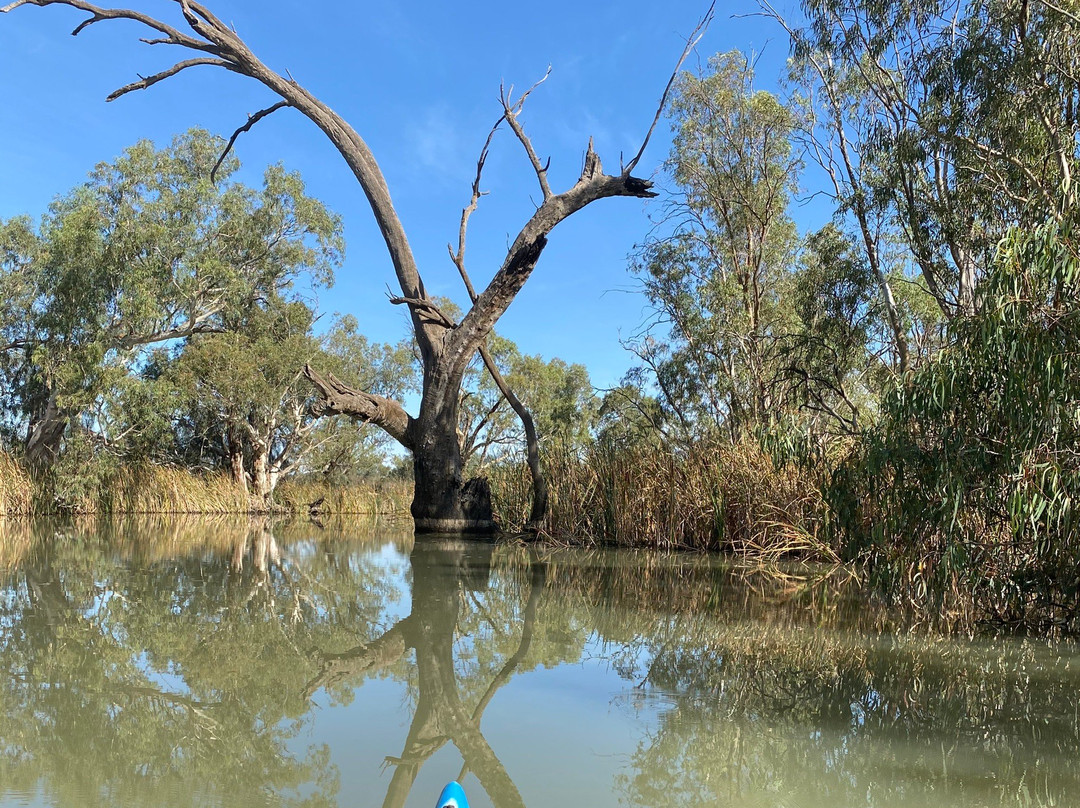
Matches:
[[777, 0, 1080, 319]]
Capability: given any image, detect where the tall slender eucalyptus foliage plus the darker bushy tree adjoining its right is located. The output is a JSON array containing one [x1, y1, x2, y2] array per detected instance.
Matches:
[[630, 52, 881, 440]]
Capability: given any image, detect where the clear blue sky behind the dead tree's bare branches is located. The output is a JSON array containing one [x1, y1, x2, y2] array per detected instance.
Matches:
[[0, 0, 812, 387]]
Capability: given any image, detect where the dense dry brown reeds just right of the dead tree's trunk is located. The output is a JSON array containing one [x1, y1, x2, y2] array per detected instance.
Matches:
[[489, 441, 837, 560]]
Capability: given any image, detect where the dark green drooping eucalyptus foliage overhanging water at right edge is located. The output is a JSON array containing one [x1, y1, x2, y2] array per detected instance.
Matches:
[[834, 221, 1080, 620]]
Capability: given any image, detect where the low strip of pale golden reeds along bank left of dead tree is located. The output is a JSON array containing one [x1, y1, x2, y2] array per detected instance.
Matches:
[[0, 453, 413, 516]]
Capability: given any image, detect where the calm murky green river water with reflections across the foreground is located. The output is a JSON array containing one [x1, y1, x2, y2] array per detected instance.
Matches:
[[0, 521, 1080, 808]]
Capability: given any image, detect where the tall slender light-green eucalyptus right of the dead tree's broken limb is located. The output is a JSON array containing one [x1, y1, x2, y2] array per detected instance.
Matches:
[[634, 51, 800, 442]]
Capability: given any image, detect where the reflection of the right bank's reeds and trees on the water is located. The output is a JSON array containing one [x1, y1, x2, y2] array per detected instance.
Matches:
[[511, 548, 1080, 806]]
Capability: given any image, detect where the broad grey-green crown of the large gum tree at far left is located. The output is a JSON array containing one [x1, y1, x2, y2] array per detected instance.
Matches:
[[0, 130, 343, 466]]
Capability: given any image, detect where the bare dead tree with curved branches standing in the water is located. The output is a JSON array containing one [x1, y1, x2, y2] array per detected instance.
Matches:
[[0, 0, 713, 533]]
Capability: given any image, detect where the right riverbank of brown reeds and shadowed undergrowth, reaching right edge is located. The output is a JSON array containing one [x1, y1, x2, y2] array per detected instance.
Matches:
[[489, 440, 1080, 634]]
